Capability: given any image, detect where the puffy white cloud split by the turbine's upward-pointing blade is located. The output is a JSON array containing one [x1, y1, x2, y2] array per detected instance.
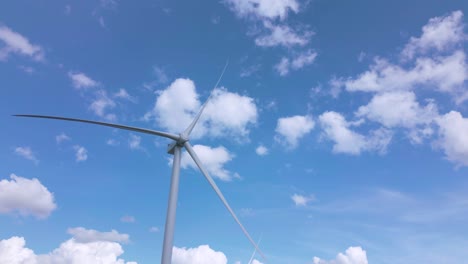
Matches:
[[144, 79, 258, 138]]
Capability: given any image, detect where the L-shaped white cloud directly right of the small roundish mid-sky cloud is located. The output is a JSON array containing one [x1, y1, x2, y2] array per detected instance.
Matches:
[[319, 111, 392, 155]]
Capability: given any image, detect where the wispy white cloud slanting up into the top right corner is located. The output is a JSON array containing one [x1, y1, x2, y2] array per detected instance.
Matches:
[[402, 11, 466, 59]]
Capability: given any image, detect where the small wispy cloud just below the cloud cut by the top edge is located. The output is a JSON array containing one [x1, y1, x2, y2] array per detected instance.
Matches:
[[255, 21, 314, 47]]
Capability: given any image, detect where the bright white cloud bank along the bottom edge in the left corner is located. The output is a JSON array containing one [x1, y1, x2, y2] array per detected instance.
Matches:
[[0, 233, 136, 264]]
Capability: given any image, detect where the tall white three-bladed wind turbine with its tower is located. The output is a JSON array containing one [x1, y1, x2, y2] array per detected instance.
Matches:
[[14, 63, 266, 264]]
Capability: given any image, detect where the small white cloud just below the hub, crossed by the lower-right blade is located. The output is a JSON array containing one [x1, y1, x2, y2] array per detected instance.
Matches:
[[180, 145, 236, 181]]
